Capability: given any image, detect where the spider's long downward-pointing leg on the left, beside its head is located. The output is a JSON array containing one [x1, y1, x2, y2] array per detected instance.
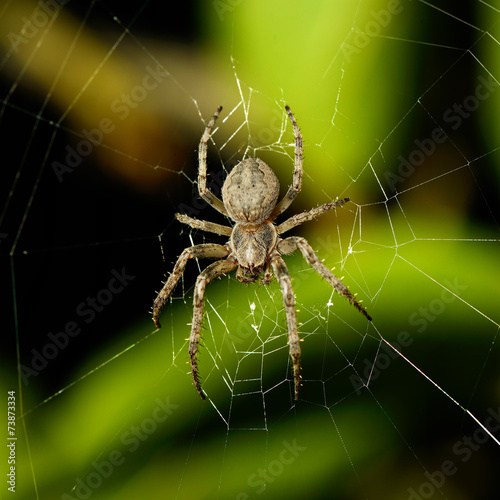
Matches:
[[189, 259, 237, 399]]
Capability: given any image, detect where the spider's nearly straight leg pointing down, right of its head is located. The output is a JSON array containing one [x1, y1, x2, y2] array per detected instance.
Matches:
[[271, 254, 300, 399]]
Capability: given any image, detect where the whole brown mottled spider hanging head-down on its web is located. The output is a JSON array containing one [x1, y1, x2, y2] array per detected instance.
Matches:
[[153, 106, 371, 399]]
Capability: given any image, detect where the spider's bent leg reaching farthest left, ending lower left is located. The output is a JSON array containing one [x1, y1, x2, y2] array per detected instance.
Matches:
[[153, 243, 229, 328]]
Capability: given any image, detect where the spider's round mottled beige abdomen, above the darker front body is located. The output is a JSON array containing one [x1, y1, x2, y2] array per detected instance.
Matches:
[[222, 158, 280, 224]]
